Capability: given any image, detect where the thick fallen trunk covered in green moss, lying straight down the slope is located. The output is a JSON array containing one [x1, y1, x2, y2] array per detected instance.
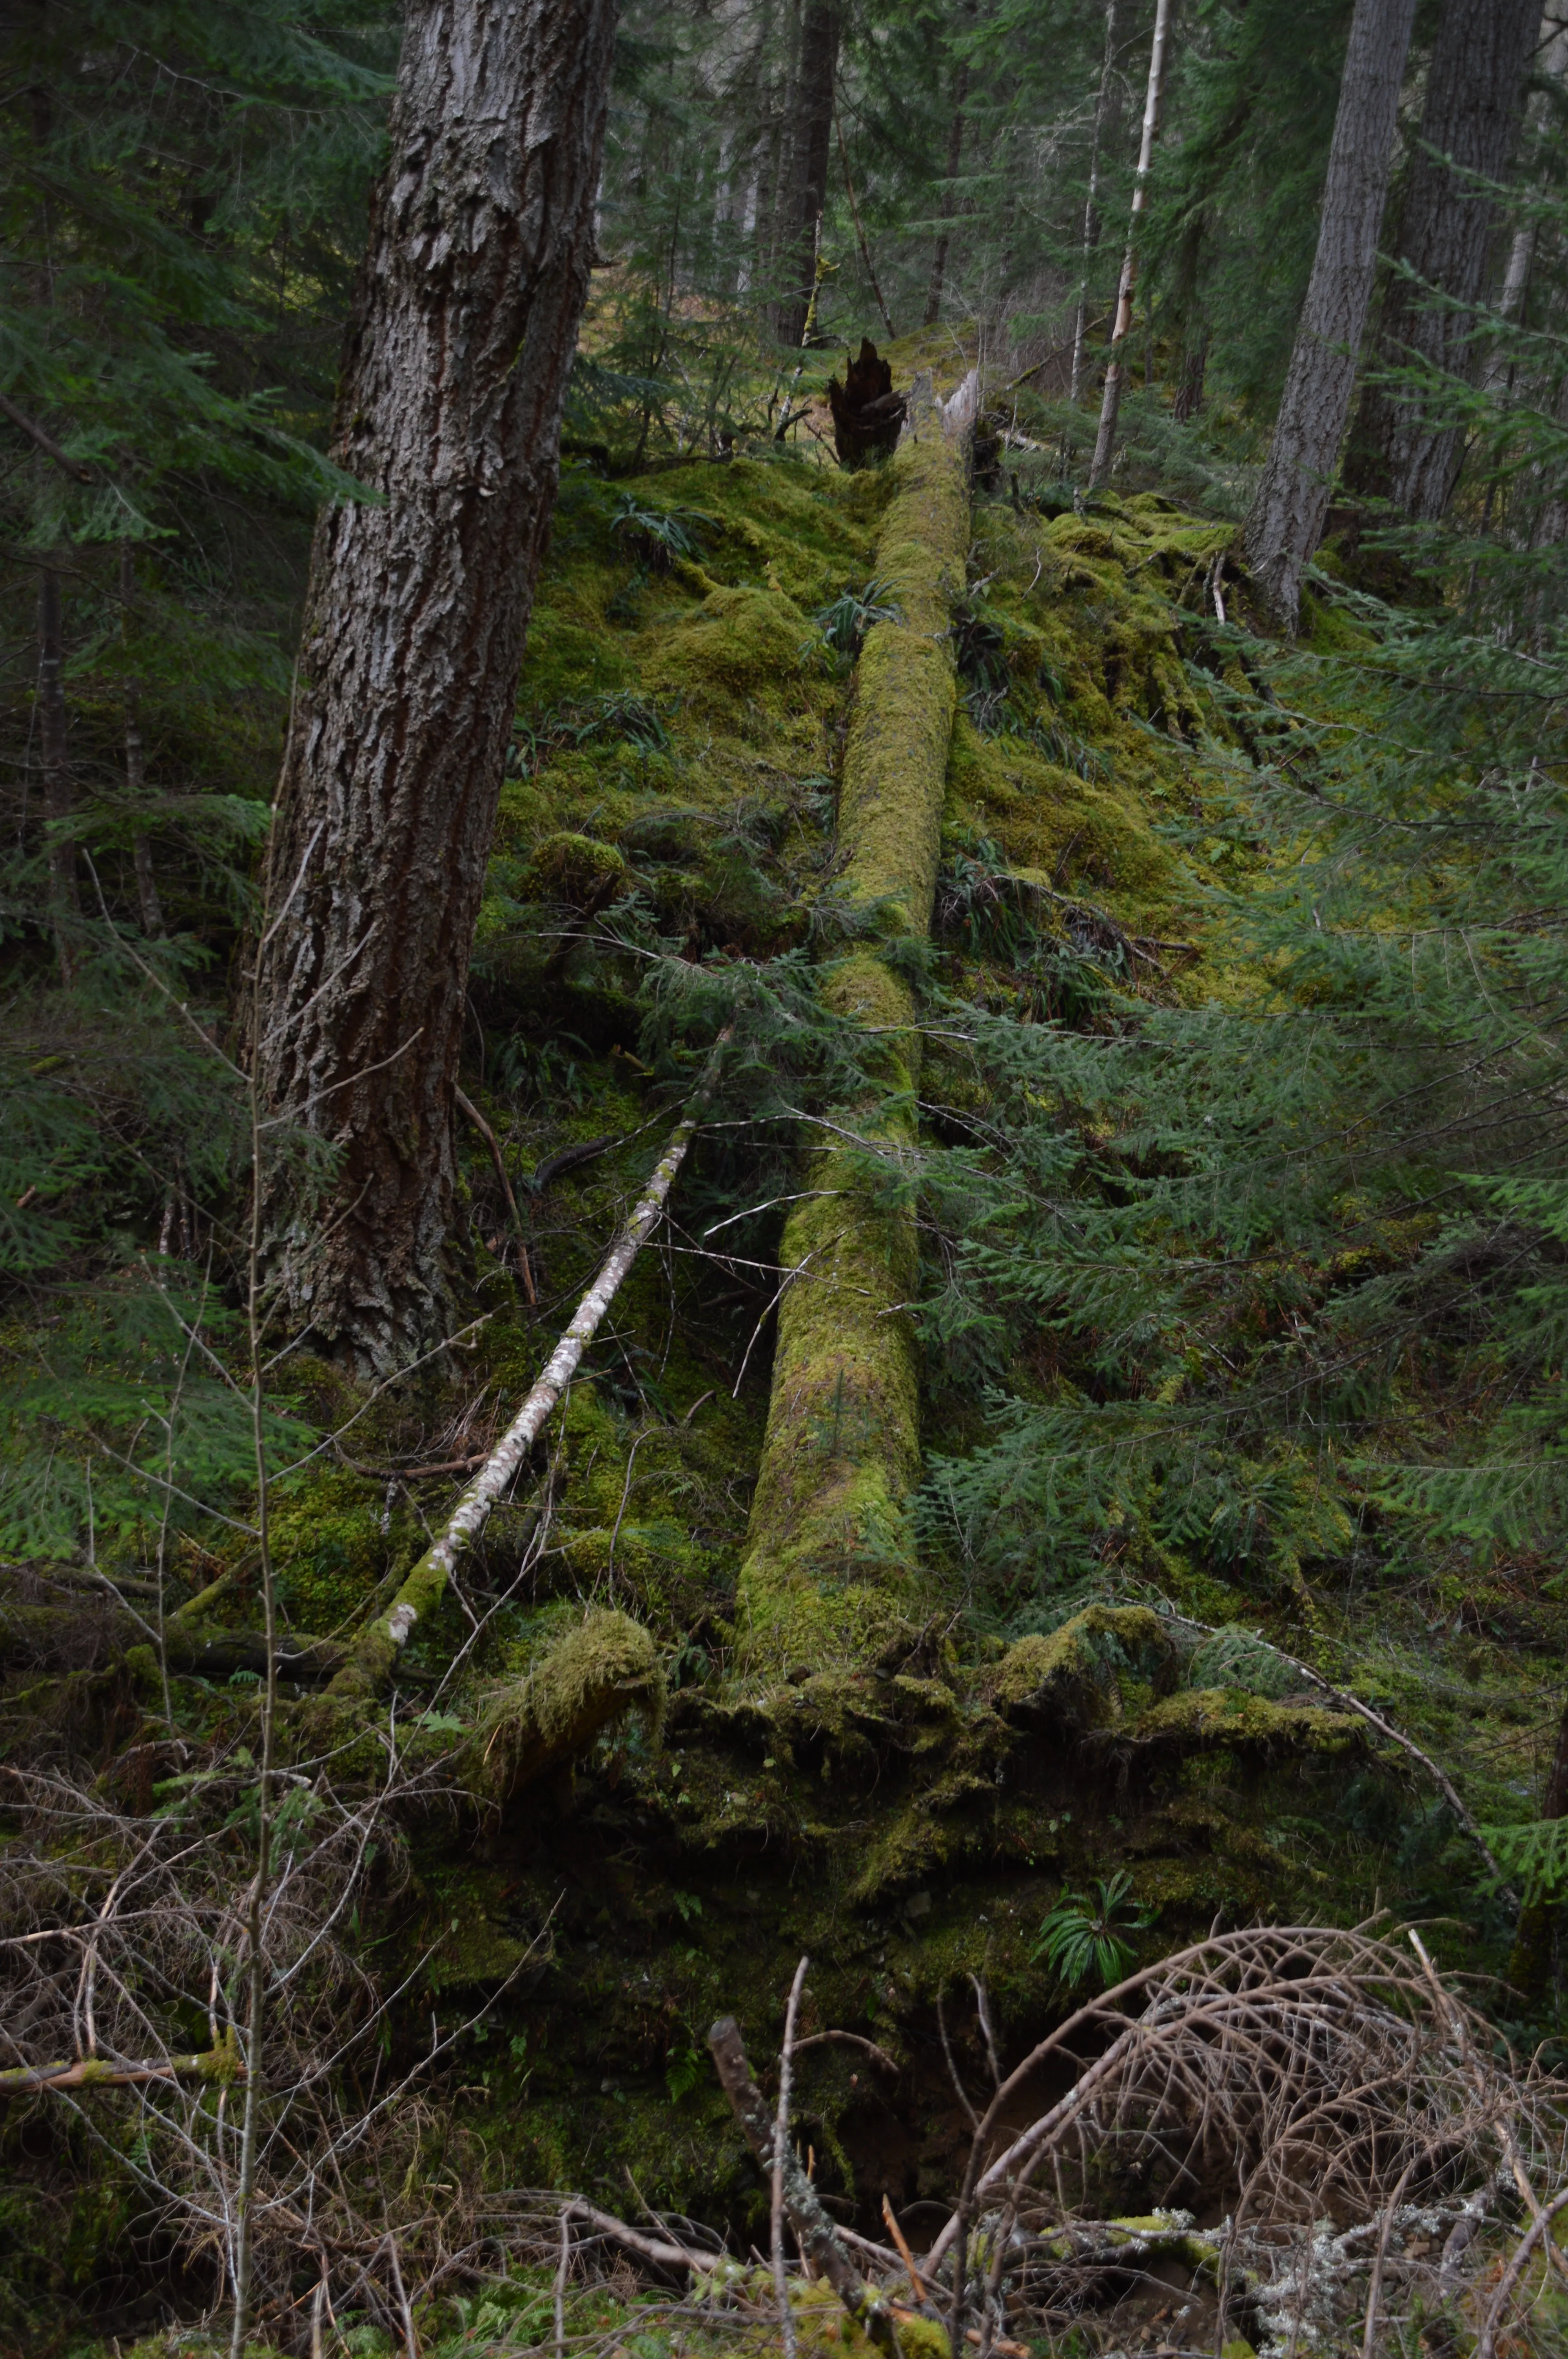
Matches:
[[740, 418, 969, 1668]]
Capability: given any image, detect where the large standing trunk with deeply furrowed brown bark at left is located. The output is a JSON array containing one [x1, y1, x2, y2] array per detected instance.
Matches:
[[255, 0, 615, 1370]]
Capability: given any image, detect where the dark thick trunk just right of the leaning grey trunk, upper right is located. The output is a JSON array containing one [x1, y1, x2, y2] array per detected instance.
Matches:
[[1344, 0, 1540, 522]]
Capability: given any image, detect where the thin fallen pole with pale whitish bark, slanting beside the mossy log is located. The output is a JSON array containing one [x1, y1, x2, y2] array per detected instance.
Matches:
[[328, 1033, 729, 1703]]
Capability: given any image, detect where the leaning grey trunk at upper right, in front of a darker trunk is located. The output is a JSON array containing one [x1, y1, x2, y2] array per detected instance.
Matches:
[[1247, 0, 1415, 630]]
